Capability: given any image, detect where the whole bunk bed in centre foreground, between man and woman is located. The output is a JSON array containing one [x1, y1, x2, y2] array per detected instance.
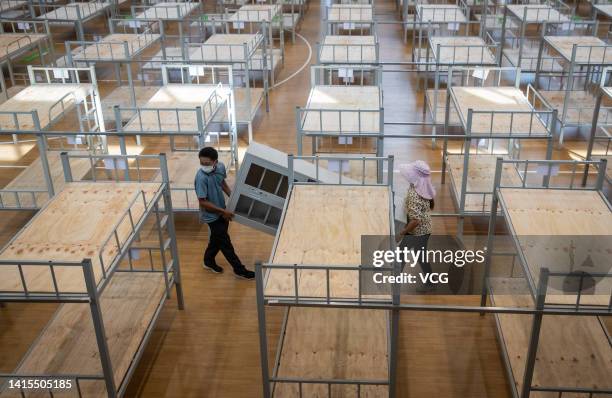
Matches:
[[256, 158, 395, 397]]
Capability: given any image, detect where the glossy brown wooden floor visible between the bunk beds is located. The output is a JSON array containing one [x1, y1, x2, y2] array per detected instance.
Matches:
[[0, 0, 600, 398]]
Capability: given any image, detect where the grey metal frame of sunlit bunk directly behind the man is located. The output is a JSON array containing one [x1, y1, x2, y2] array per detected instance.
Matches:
[[114, 64, 238, 211]]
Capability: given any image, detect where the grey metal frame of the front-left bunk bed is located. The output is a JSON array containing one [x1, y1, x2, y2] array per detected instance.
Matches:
[[0, 153, 184, 397]]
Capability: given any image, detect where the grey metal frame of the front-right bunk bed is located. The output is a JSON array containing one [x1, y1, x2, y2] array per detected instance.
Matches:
[[481, 158, 612, 398]]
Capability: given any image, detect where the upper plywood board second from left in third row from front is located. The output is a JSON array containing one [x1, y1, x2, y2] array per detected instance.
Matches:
[[72, 33, 161, 60]]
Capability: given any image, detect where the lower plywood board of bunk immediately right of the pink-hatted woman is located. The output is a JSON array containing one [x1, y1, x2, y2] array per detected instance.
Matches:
[[446, 154, 521, 214]]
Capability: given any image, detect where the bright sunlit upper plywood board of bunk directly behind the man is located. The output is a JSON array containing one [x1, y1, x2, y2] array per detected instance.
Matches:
[[123, 84, 222, 132]]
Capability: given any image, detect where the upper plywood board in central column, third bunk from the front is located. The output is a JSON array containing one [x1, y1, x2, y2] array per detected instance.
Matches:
[[319, 35, 377, 64]]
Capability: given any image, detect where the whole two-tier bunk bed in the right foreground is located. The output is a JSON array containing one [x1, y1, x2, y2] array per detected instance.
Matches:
[[487, 159, 612, 396]]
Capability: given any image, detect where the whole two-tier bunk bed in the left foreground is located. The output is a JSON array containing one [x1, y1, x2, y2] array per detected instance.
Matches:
[[0, 154, 183, 397]]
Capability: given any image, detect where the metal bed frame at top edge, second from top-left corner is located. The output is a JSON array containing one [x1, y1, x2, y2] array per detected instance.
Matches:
[[29, 0, 113, 40]]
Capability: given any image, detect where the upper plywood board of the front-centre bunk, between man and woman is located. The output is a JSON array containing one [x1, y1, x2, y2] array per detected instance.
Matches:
[[265, 185, 392, 297]]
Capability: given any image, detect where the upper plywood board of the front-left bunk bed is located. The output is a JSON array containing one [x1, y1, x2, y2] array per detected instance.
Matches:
[[0, 182, 160, 292]]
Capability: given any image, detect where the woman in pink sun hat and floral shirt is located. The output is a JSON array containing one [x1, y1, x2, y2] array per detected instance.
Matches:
[[400, 160, 436, 273]]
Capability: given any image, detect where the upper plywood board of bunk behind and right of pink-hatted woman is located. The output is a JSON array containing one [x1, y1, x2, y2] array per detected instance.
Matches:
[[451, 87, 547, 136]]
